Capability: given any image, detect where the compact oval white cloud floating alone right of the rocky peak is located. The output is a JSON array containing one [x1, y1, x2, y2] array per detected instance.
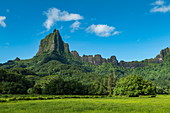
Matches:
[[86, 24, 121, 37]]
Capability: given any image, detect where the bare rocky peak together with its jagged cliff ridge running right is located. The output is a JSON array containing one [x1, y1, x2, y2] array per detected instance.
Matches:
[[1, 29, 170, 68]]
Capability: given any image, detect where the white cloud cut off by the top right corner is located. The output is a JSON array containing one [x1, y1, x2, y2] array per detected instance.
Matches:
[[150, 0, 170, 13]]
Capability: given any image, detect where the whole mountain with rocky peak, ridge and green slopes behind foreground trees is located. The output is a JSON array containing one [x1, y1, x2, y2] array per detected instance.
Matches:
[[0, 29, 170, 94]]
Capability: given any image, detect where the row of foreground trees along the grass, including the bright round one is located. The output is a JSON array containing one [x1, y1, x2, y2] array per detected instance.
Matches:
[[0, 69, 156, 97]]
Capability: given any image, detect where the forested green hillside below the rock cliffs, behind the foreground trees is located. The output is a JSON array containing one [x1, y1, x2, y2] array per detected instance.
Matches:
[[0, 46, 170, 95]]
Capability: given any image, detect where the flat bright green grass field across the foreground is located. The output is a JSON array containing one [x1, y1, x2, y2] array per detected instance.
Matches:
[[0, 95, 170, 113]]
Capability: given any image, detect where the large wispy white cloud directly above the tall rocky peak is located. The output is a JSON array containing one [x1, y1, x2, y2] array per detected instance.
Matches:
[[43, 8, 83, 30]]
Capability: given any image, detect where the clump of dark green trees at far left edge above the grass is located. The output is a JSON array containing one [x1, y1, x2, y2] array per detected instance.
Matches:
[[0, 69, 33, 94]]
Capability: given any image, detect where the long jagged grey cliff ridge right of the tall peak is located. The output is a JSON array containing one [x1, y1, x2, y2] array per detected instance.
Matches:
[[71, 47, 170, 68]]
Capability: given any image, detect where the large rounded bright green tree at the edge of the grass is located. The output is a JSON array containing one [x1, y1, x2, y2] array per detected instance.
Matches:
[[114, 76, 156, 97]]
